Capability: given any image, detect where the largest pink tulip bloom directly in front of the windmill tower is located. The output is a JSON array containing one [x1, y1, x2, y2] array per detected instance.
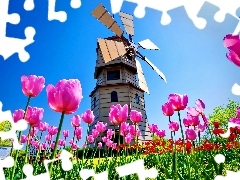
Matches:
[[110, 104, 128, 124]]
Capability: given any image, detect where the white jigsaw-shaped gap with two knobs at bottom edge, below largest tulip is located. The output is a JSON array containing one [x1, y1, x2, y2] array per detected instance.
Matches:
[[21, 150, 73, 180]]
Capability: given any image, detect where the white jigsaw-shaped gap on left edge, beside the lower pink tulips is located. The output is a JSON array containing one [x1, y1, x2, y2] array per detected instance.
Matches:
[[0, 101, 28, 150]]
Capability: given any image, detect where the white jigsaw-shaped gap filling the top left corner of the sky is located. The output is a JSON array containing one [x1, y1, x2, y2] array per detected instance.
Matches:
[[0, 0, 36, 62]]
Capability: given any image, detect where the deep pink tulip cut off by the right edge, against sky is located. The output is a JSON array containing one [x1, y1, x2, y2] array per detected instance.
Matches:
[[223, 34, 240, 67]]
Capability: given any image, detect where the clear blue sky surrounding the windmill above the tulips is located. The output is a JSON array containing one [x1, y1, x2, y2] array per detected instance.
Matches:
[[0, 0, 240, 145]]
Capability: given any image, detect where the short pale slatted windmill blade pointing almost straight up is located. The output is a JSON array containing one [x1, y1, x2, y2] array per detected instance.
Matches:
[[119, 12, 134, 36]]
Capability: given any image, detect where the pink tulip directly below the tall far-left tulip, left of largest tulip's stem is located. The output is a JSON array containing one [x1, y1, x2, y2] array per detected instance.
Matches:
[[26, 106, 44, 127]]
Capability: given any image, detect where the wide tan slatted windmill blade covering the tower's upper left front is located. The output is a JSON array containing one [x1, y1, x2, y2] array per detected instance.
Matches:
[[98, 39, 127, 63]]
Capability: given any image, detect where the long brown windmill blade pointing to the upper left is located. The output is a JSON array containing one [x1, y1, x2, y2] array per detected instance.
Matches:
[[91, 4, 123, 37]]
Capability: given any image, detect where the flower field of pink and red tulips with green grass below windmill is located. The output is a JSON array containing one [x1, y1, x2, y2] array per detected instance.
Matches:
[[0, 75, 240, 180]]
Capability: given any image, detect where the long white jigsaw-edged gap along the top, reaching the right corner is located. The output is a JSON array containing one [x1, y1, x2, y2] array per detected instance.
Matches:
[[110, 0, 240, 29]]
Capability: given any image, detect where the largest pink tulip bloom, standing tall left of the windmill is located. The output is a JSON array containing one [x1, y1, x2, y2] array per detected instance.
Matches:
[[46, 79, 83, 114]]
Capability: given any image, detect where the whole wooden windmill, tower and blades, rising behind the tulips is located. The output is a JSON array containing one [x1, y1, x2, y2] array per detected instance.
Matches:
[[89, 4, 166, 146]]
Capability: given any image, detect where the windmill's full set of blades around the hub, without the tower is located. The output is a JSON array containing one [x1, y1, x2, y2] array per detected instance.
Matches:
[[91, 4, 167, 94]]
